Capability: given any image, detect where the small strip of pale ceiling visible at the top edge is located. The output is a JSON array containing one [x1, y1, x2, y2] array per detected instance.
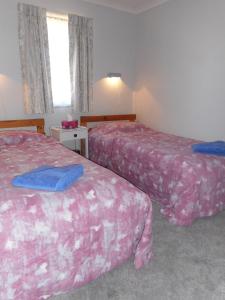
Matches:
[[84, 0, 168, 14]]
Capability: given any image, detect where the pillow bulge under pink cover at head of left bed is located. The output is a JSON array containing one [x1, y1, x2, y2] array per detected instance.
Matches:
[[0, 130, 44, 145]]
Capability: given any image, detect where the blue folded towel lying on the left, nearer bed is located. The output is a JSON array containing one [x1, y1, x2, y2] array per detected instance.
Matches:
[[12, 164, 84, 192]]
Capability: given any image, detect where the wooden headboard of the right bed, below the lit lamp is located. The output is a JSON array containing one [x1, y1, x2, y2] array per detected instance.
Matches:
[[80, 114, 136, 127]]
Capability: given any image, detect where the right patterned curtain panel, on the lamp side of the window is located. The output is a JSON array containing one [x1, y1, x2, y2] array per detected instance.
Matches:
[[68, 15, 93, 112]]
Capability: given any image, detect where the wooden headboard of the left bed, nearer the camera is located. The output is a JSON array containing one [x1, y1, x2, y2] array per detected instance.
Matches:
[[0, 119, 45, 134]]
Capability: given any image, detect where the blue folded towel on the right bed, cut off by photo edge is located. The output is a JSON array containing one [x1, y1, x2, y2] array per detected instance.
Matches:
[[192, 141, 225, 156]]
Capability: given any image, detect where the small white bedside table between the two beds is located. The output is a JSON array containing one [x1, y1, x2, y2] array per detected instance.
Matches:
[[51, 126, 88, 158]]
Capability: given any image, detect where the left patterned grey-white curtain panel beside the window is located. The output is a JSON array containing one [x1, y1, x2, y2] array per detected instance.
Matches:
[[18, 3, 53, 114]]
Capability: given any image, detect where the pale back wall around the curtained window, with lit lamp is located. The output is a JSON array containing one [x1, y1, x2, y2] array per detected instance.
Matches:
[[0, 0, 135, 132]]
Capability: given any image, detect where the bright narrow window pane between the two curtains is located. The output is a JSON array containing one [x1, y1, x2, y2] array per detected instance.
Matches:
[[47, 13, 71, 107]]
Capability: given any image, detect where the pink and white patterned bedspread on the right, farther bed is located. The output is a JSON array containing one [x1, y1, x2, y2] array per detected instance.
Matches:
[[89, 122, 225, 225]]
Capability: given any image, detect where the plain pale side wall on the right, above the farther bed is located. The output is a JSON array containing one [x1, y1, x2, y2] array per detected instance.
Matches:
[[134, 0, 225, 140]]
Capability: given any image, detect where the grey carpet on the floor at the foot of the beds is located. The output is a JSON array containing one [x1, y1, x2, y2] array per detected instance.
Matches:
[[52, 204, 225, 300]]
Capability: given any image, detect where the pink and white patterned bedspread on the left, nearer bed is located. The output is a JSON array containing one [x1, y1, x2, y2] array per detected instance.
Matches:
[[0, 133, 152, 300]]
